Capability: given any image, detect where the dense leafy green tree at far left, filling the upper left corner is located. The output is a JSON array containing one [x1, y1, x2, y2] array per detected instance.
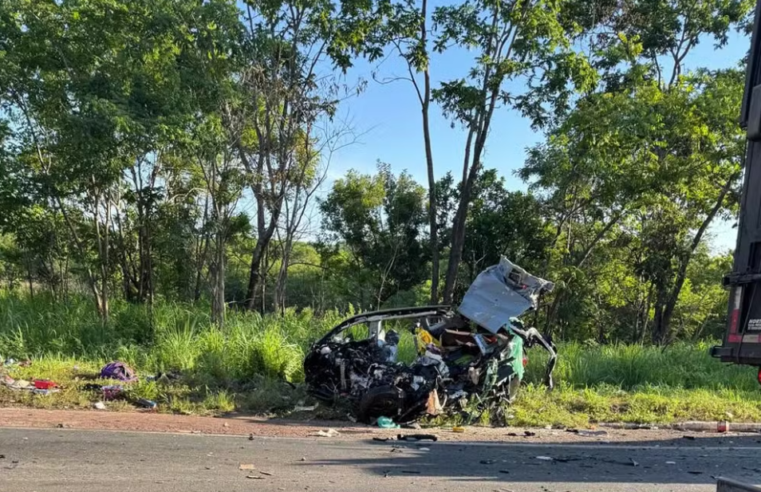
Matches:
[[0, 0, 243, 321]]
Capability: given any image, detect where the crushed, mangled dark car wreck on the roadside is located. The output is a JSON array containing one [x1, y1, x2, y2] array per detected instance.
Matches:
[[304, 257, 556, 423]]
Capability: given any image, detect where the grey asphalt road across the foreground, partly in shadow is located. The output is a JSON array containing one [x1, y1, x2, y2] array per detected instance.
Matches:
[[0, 429, 761, 492]]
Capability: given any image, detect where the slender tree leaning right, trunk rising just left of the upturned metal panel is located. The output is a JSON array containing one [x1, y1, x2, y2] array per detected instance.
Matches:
[[433, 0, 595, 303]]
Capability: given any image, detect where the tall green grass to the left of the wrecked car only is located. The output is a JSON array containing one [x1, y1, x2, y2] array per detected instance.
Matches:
[[0, 296, 342, 384]]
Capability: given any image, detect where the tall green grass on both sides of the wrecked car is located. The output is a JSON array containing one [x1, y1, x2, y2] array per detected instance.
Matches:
[[0, 294, 758, 392]]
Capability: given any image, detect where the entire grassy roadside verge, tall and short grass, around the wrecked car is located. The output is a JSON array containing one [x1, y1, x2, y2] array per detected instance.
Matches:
[[0, 296, 761, 426]]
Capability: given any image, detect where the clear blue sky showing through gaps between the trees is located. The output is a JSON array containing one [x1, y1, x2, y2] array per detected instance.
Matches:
[[326, 32, 749, 254]]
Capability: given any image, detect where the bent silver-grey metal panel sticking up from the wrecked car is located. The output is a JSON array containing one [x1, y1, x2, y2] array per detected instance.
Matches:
[[457, 256, 555, 333]]
